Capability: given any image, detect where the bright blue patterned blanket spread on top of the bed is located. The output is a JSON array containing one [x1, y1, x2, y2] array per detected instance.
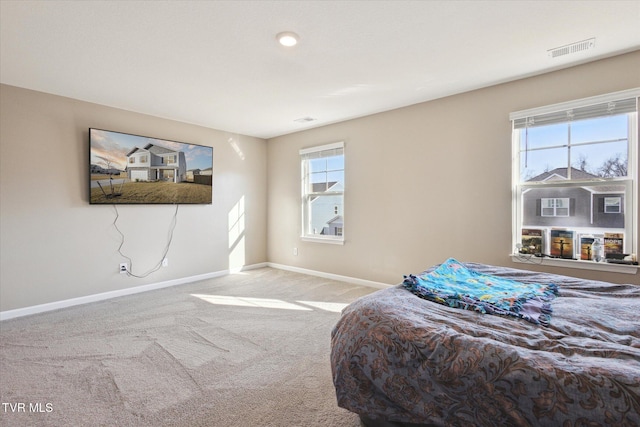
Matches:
[[403, 258, 558, 326]]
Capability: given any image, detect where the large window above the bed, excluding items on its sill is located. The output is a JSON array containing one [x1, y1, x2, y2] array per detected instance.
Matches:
[[510, 88, 640, 268]]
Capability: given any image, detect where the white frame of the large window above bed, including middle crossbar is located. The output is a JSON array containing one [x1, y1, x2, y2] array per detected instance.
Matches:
[[509, 88, 640, 274]]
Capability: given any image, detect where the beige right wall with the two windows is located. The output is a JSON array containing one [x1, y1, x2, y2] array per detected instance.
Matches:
[[268, 51, 640, 283]]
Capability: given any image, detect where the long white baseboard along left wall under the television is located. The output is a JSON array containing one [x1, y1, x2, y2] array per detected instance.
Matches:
[[0, 262, 268, 321]]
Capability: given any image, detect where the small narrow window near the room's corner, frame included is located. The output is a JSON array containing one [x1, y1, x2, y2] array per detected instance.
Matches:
[[300, 142, 344, 244]]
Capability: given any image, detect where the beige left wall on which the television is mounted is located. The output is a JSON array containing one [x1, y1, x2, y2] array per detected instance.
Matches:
[[0, 85, 267, 311]]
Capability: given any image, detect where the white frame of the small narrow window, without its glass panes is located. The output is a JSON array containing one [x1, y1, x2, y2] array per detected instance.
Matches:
[[300, 141, 346, 245]]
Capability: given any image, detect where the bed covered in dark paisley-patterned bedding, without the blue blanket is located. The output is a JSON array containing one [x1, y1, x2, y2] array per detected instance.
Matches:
[[331, 263, 640, 427]]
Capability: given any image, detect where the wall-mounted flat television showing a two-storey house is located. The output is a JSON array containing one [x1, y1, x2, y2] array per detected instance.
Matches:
[[89, 128, 213, 205]]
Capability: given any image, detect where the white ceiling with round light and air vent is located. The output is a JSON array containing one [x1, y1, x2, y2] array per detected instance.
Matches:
[[0, 0, 640, 138]]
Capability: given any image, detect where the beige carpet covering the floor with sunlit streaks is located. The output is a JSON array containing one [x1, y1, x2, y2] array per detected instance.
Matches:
[[0, 268, 375, 427]]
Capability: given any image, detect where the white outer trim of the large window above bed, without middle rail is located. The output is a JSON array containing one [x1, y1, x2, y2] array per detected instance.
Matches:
[[509, 87, 640, 274]]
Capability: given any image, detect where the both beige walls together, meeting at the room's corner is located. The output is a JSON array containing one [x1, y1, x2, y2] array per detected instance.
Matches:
[[0, 52, 640, 311]]
